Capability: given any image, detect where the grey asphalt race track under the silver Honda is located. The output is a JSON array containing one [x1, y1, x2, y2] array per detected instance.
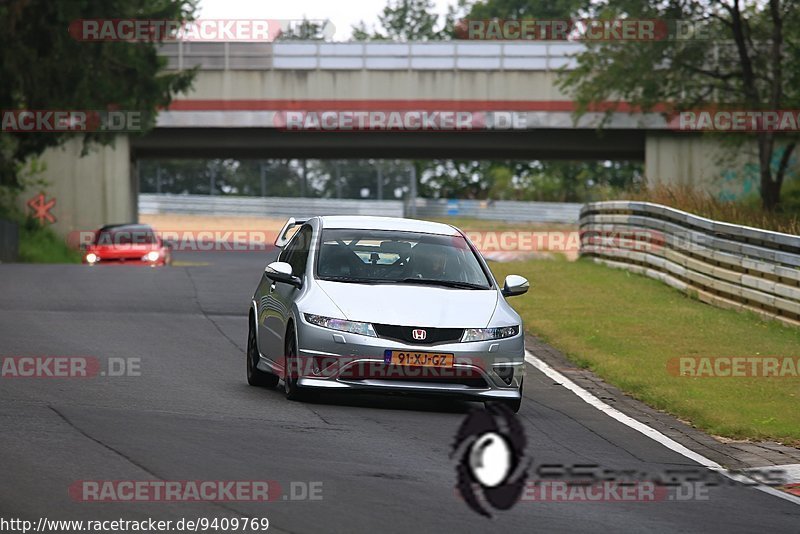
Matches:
[[0, 252, 800, 533]]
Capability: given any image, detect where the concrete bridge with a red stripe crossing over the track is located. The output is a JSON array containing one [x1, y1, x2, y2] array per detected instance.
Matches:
[[29, 42, 756, 237]]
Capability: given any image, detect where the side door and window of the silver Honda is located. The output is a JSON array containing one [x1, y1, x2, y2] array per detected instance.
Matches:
[[260, 225, 313, 365]]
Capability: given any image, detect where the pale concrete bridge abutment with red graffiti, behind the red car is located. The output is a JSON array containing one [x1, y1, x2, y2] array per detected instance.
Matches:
[[20, 135, 138, 236]]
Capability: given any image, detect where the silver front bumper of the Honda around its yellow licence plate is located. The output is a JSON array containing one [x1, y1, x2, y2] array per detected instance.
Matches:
[[295, 320, 525, 400]]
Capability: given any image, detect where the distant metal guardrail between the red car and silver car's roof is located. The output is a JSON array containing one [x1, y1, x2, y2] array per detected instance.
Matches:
[[139, 193, 403, 219]]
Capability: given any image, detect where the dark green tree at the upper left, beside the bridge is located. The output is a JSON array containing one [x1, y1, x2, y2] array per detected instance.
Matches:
[[0, 0, 195, 199]]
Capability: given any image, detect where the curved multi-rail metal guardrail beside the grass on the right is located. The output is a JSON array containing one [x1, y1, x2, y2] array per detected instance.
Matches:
[[580, 201, 800, 325]]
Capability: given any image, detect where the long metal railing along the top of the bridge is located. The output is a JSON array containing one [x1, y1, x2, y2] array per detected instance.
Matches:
[[159, 41, 585, 71]]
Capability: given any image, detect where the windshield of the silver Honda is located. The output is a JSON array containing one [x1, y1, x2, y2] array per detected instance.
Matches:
[[317, 229, 492, 289]]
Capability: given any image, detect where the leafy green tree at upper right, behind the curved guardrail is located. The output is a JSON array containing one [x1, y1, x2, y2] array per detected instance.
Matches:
[[561, 0, 800, 210]]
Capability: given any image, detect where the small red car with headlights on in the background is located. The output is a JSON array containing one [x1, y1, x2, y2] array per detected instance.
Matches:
[[83, 224, 172, 266]]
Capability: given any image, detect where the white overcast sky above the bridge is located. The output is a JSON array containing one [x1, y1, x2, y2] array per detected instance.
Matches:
[[198, 0, 455, 41]]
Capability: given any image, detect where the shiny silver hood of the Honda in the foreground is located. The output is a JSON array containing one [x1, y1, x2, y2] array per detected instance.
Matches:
[[317, 280, 499, 328]]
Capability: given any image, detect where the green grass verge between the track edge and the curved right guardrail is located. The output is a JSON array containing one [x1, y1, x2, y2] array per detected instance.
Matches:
[[491, 259, 800, 446]]
